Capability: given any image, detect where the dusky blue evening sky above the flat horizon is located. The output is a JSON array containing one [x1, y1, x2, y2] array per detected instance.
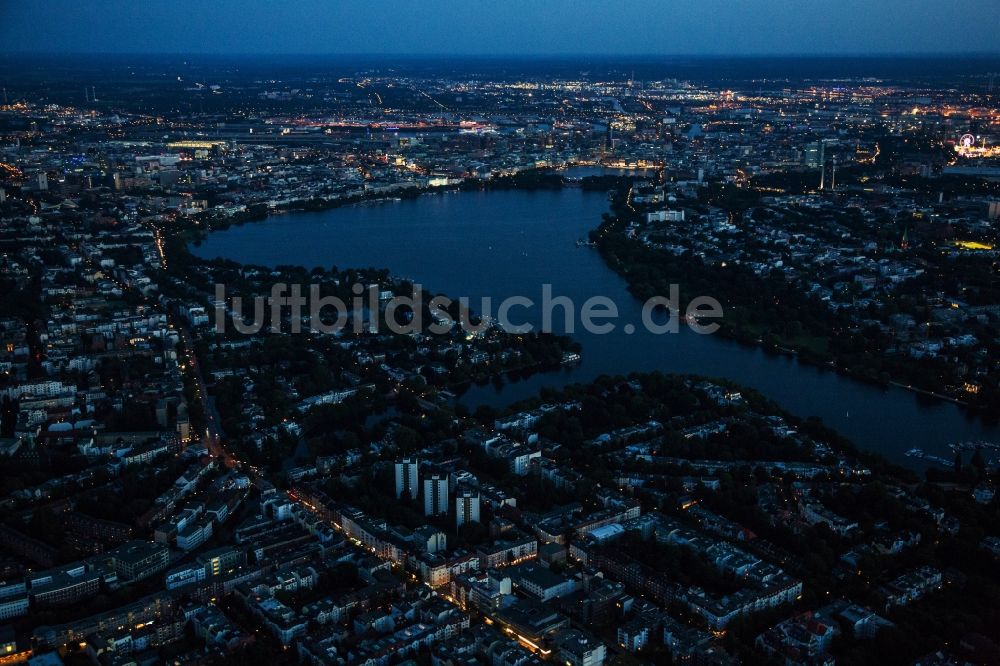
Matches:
[[0, 0, 1000, 55]]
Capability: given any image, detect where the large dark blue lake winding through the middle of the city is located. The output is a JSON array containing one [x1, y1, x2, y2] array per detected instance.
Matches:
[[192, 189, 1000, 469]]
